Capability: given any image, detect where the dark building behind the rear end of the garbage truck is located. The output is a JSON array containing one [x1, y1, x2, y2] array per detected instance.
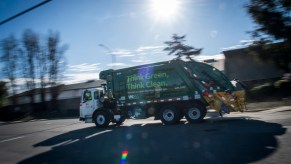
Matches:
[[223, 44, 284, 85]]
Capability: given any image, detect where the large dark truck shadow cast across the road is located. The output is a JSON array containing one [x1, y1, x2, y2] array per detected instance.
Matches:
[[20, 117, 286, 164]]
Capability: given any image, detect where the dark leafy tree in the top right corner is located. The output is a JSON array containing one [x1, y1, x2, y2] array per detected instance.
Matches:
[[245, 0, 291, 72]]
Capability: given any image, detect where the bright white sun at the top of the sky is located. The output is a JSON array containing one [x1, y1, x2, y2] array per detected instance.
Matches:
[[151, 0, 179, 20]]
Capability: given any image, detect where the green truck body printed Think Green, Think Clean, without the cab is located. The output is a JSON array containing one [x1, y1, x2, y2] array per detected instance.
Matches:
[[99, 60, 234, 106]]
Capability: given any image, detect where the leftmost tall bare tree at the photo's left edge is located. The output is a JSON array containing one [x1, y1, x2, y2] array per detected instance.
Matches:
[[0, 35, 20, 105]]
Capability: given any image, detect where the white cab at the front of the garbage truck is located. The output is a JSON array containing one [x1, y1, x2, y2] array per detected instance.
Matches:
[[80, 88, 104, 123]]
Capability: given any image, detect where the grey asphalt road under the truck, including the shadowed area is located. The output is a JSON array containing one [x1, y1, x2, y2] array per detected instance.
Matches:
[[0, 106, 291, 164]]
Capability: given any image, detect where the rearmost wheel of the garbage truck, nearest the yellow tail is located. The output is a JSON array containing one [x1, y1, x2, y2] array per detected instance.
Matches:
[[185, 104, 207, 123]]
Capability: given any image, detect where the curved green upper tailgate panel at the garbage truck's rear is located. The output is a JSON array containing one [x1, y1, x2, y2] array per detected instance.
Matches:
[[186, 61, 234, 90]]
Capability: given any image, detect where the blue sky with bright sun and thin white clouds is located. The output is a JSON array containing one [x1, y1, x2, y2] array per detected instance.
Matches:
[[0, 0, 254, 84]]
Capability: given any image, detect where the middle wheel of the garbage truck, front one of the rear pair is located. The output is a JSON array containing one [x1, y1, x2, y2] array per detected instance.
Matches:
[[160, 106, 180, 125]]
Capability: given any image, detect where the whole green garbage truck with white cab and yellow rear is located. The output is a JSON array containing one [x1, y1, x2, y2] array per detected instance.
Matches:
[[80, 59, 246, 127]]
